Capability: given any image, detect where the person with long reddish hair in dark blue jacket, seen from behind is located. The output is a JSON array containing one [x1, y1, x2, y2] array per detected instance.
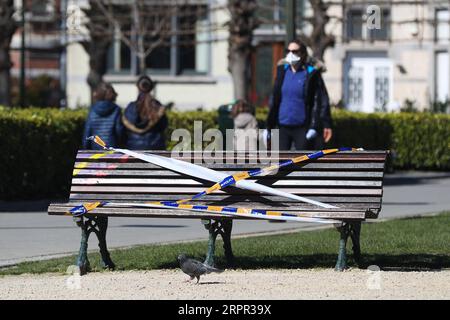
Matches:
[[122, 76, 168, 150]]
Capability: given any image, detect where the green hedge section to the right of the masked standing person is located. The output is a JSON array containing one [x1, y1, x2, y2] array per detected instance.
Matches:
[[331, 110, 450, 170]]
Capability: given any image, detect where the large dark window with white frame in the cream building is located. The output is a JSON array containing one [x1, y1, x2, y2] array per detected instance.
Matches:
[[107, 5, 210, 75]]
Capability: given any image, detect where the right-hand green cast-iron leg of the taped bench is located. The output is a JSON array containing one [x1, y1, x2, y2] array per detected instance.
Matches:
[[335, 221, 361, 271]]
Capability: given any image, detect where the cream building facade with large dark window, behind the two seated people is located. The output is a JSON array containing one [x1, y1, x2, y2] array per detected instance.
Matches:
[[67, 0, 233, 110]]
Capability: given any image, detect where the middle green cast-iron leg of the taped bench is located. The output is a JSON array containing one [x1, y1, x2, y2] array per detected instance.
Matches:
[[202, 219, 234, 267]]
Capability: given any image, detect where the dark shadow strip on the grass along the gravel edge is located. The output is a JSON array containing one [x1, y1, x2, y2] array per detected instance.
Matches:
[[158, 254, 450, 271]]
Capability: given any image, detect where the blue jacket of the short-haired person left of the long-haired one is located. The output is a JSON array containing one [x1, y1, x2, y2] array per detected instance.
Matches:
[[82, 101, 123, 150]]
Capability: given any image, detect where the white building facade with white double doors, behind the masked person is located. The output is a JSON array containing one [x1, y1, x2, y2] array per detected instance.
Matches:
[[253, 0, 450, 112]]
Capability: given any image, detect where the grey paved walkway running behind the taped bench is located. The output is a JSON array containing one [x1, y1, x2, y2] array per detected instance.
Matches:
[[0, 172, 450, 266]]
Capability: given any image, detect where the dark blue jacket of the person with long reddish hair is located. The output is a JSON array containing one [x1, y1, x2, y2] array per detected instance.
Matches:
[[122, 102, 168, 150]]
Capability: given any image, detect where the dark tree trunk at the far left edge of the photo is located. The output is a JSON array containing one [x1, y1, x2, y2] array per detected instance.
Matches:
[[0, 0, 17, 105]]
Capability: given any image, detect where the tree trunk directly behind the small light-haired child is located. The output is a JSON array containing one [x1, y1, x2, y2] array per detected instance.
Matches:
[[227, 0, 258, 99]]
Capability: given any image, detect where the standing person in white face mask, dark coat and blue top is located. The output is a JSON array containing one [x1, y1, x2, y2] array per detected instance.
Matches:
[[267, 40, 331, 150]]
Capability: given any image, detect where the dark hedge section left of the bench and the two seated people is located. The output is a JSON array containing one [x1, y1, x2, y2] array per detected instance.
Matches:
[[0, 107, 87, 199]]
